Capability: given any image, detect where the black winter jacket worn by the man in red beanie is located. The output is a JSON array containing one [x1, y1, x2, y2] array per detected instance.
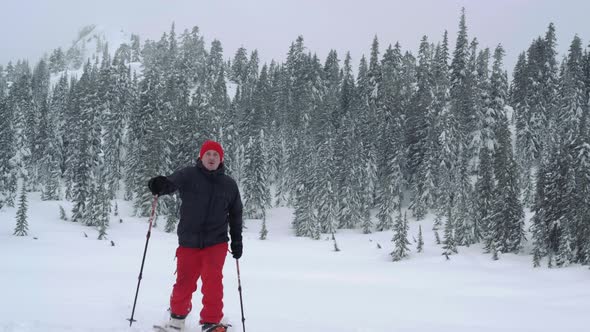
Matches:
[[162, 159, 242, 248]]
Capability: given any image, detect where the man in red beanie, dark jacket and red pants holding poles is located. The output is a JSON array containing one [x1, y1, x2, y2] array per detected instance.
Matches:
[[148, 141, 242, 332]]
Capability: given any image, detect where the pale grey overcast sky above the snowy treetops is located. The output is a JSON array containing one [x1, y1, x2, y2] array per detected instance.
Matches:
[[0, 0, 590, 71]]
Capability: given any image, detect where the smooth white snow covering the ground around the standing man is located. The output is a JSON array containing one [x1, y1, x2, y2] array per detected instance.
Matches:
[[0, 193, 590, 332]]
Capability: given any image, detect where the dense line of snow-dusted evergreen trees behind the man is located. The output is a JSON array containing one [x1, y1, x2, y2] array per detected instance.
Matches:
[[0, 12, 590, 266]]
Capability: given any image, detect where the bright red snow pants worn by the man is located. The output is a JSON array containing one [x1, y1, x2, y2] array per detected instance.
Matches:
[[170, 242, 227, 324]]
